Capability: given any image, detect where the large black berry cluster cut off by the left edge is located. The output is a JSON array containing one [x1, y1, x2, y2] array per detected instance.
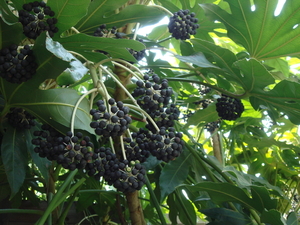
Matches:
[[0, 44, 37, 84]]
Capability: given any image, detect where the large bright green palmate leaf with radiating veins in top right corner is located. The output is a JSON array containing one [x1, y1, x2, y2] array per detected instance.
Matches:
[[200, 0, 300, 60]]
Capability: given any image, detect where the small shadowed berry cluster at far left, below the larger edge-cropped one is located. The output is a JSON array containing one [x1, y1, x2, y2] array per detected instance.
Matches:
[[6, 108, 36, 129]]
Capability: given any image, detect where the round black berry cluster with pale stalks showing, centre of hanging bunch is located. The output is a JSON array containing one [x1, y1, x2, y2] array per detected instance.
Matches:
[[90, 98, 132, 138]]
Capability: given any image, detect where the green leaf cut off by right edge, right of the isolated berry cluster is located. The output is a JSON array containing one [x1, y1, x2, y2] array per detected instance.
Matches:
[[250, 80, 300, 124]]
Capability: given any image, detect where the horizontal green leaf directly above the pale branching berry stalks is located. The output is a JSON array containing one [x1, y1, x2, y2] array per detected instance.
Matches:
[[59, 34, 145, 62]]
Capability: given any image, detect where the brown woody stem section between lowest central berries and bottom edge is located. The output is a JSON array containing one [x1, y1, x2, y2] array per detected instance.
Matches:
[[126, 191, 146, 225]]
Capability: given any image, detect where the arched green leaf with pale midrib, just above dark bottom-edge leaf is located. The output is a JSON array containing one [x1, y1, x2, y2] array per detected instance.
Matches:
[[179, 182, 258, 210]]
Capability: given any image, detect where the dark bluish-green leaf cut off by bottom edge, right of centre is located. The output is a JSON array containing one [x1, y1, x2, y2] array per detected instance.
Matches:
[[200, 208, 252, 225]]
